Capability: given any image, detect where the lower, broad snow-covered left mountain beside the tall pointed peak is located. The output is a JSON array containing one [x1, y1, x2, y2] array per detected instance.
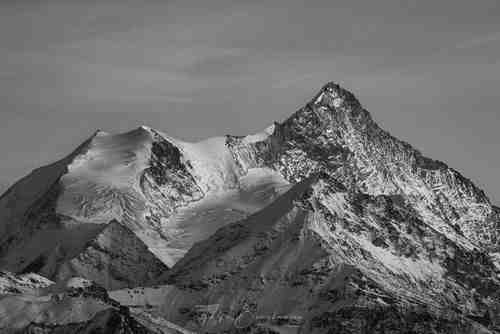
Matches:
[[0, 120, 287, 288]]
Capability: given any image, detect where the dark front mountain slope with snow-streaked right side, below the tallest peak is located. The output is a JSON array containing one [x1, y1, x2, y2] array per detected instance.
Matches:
[[154, 175, 500, 333]]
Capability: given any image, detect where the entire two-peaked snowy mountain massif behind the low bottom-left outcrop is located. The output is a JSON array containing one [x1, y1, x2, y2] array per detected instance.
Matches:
[[0, 83, 500, 333]]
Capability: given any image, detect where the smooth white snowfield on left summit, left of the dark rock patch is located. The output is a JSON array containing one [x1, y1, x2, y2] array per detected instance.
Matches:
[[57, 128, 152, 223]]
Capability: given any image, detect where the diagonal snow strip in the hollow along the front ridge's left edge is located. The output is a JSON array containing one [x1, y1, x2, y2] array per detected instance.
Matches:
[[136, 168, 290, 266]]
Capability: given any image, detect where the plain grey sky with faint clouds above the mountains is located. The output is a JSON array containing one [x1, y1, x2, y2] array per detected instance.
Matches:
[[0, 0, 500, 203]]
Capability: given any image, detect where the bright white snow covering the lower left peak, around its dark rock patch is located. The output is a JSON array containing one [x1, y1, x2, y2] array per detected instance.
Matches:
[[13, 126, 287, 265]]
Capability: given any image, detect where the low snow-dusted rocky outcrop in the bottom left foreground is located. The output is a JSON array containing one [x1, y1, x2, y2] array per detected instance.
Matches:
[[0, 276, 164, 334]]
